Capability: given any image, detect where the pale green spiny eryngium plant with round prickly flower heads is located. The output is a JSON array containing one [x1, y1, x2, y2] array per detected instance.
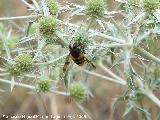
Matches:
[[0, 0, 160, 120]]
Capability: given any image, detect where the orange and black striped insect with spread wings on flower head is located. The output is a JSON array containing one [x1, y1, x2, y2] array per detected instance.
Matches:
[[63, 42, 95, 72]]
